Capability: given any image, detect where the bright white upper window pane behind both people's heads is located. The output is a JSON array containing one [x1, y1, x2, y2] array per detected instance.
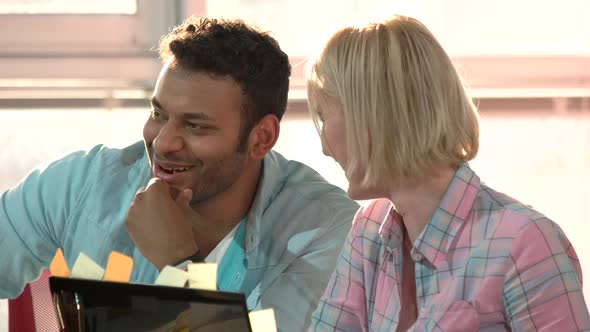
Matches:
[[207, 0, 590, 56]]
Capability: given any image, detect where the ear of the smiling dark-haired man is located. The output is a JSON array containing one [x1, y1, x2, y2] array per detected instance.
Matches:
[[248, 114, 281, 160]]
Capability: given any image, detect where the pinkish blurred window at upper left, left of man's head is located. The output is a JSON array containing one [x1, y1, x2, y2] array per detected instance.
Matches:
[[0, 0, 177, 86]]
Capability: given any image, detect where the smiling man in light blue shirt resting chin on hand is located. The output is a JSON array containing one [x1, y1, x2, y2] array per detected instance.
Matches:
[[0, 18, 358, 331]]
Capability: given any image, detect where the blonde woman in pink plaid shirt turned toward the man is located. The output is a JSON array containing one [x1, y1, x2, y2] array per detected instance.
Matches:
[[307, 16, 590, 331]]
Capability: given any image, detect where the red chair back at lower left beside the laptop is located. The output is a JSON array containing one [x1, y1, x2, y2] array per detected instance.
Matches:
[[8, 270, 59, 332]]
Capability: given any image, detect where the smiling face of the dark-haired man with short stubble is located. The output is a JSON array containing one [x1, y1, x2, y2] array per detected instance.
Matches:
[[143, 62, 248, 204]]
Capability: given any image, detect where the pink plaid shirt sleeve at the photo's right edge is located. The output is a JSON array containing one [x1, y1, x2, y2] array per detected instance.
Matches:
[[504, 218, 590, 331]]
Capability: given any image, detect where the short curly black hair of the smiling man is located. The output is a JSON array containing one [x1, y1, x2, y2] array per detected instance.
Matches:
[[159, 16, 291, 148]]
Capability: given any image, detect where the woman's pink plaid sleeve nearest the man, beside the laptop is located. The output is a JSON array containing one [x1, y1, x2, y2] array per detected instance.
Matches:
[[309, 208, 368, 331]]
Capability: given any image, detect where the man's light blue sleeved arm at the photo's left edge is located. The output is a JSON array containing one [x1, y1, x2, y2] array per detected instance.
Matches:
[[0, 151, 96, 298]]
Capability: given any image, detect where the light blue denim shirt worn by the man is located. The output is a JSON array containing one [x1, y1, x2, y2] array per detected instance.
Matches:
[[0, 142, 358, 331]]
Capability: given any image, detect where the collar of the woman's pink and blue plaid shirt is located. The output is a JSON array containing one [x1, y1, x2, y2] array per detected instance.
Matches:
[[379, 163, 480, 269]]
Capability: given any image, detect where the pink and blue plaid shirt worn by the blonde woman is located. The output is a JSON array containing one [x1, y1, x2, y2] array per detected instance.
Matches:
[[310, 164, 590, 332]]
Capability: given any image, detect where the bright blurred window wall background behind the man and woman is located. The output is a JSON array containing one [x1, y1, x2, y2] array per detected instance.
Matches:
[[0, 0, 590, 331]]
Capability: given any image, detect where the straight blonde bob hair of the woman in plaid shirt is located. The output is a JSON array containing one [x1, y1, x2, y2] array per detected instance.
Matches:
[[306, 15, 479, 186]]
